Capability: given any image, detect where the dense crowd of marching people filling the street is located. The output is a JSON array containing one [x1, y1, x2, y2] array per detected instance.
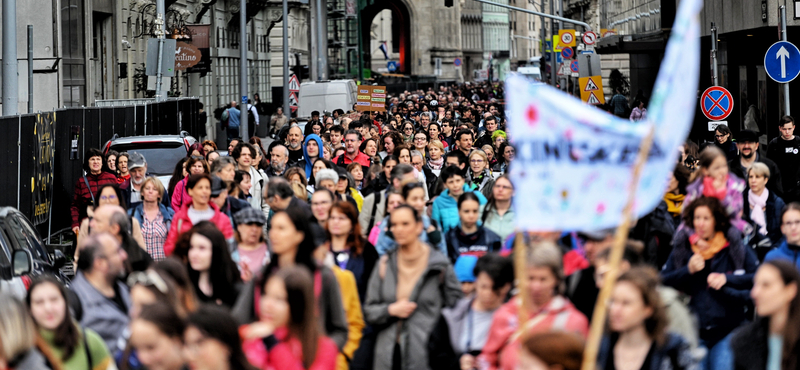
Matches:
[[0, 84, 800, 370]]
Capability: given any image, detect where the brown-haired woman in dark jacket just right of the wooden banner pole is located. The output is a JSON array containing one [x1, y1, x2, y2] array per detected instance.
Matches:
[[597, 267, 697, 370]]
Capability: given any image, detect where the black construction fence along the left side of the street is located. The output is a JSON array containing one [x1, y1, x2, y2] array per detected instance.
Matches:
[[0, 98, 199, 237]]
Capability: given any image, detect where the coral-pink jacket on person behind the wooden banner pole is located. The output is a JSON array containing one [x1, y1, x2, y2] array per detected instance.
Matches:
[[478, 296, 589, 370]]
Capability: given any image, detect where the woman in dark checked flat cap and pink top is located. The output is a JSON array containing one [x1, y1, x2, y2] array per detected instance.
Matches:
[[233, 207, 270, 281]]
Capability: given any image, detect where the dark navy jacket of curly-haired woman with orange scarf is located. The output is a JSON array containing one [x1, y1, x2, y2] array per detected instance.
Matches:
[[661, 227, 758, 343]]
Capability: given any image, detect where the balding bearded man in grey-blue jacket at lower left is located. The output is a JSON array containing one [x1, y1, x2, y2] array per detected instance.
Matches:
[[70, 233, 131, 351]]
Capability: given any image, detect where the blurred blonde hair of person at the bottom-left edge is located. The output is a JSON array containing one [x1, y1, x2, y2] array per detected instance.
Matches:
[[0, 293, 37, 361]]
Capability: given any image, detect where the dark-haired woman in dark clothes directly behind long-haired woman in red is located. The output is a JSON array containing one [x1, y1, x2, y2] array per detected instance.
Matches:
[[232, 208, 347, 348]]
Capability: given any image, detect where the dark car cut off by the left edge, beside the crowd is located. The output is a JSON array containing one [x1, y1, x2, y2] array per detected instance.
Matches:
[[0, 207, 68, 297]]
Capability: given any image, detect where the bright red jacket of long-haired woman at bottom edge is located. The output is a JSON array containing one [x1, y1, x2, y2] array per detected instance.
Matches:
[[240, 327, 339, 370]]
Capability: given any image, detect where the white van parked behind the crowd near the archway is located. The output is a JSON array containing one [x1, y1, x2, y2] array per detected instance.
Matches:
[[297, 80, 358, 118]]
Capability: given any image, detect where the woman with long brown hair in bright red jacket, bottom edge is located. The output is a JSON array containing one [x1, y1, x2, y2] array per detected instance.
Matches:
[[240, 265, 339, 370]]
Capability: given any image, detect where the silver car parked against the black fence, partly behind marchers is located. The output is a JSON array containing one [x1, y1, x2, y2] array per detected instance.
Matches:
[[103, 131, 197, 187]]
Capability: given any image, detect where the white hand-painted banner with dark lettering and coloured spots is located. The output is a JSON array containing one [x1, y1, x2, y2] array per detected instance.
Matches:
[[506, 0, 702, 231]]
